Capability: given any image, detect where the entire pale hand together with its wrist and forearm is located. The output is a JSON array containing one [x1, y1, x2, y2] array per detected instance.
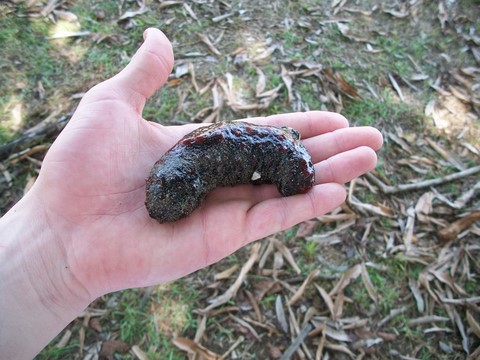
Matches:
[[0, 29, 382, 359]]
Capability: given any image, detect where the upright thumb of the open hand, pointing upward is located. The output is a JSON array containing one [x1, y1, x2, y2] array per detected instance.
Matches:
[[108, 28, 173, 112]]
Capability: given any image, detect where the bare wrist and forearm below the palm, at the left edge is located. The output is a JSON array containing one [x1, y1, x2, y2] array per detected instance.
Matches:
[[0, 194, 93, 359]]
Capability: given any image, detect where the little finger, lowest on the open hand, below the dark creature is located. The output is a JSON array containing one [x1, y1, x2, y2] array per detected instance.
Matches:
[[246, 183, 346, 243]]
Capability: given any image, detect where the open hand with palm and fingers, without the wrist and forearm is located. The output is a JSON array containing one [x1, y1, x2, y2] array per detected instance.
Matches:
[[32, 29, 382, 297]]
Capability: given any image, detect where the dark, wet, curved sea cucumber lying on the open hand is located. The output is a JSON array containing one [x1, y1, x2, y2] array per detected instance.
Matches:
[[145, 121, 315, 223]]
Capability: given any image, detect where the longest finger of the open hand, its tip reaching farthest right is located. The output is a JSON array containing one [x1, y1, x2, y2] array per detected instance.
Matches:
[[303, 126, 383, 163]]
